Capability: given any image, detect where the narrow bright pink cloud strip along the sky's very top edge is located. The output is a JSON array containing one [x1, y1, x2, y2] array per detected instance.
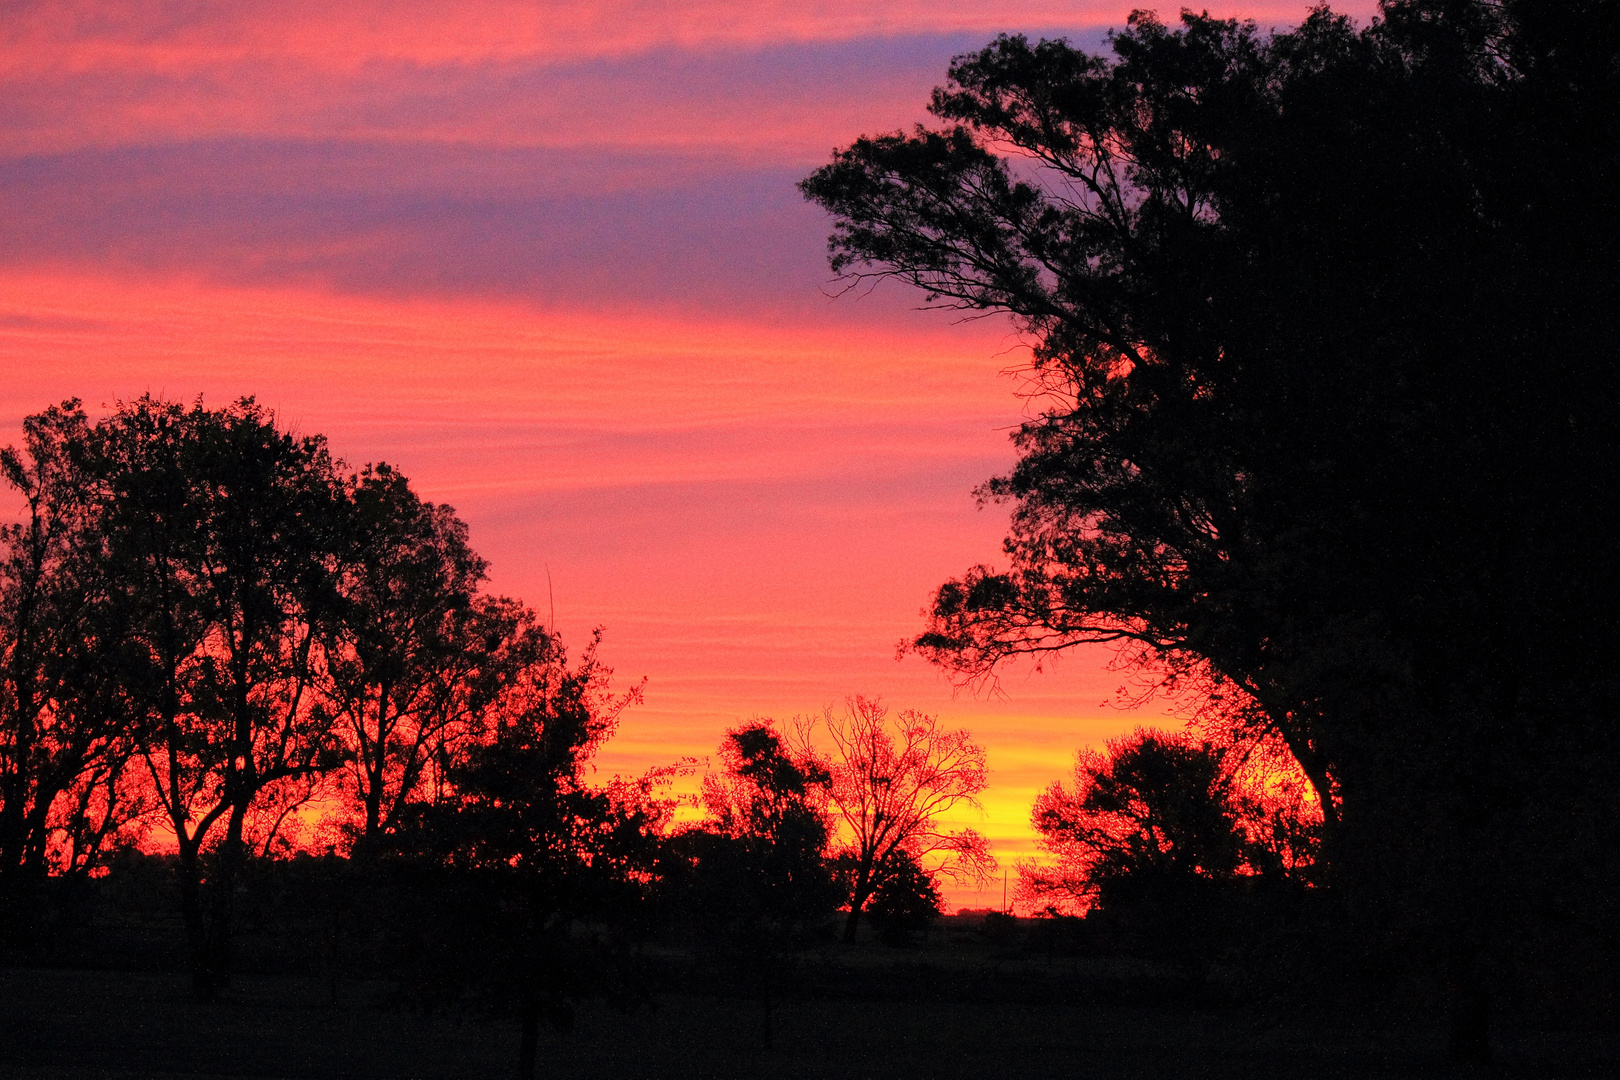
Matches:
[[3, 0, 1375, 73]]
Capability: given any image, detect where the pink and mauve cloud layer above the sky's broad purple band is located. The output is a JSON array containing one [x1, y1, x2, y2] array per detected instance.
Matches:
[[0, 2, 1371, 162]]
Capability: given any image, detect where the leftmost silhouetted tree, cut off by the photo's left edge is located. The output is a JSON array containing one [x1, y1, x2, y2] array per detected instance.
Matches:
[[0, 402, 146, 950]]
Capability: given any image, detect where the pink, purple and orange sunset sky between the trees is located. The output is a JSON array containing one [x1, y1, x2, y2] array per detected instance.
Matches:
[[0, 0, 1372, 905]]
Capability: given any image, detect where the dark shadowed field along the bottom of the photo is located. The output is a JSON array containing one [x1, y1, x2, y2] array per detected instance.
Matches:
[[0, 968, 1620, 1080]]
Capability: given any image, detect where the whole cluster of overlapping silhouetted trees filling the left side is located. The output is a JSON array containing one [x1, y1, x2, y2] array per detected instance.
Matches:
[[0, 397, 667, 1072]]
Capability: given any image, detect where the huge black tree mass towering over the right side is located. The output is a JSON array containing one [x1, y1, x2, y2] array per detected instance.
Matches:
[[804, 0, 1620, 1054]]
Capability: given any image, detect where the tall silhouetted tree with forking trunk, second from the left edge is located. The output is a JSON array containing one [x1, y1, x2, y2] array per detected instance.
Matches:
[[96, 397, 340, 996]]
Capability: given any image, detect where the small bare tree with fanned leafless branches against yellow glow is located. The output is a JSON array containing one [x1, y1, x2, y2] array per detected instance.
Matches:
[[823, 696, 995, 941]]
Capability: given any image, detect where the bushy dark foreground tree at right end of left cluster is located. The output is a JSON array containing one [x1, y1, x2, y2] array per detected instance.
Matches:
[[389, 636, 664, 1077]]
